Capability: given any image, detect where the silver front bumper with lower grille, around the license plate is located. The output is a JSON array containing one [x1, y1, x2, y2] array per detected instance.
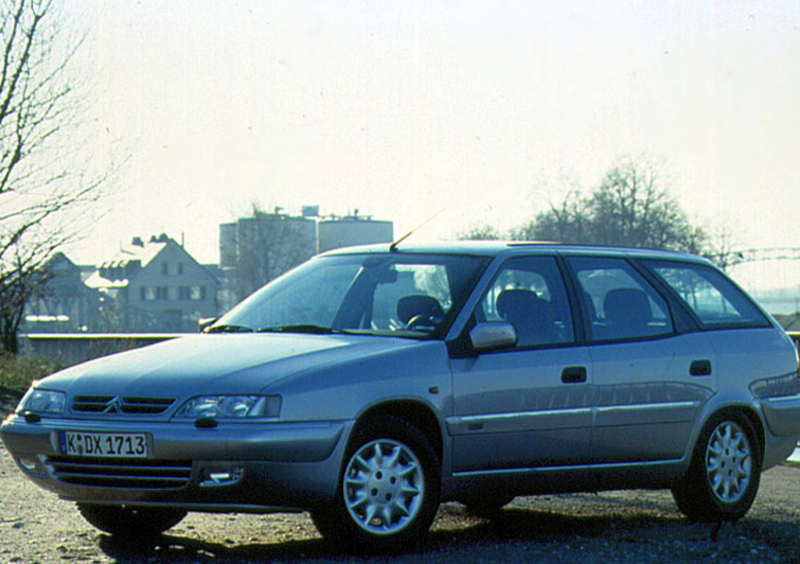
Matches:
[[0, 415, 352, 512]]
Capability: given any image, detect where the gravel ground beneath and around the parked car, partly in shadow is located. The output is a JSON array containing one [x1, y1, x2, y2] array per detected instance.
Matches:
[[0, 396, 800, 564]]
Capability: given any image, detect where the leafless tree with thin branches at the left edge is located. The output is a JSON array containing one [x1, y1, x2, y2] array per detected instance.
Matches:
[[0, 0, 100, 353]]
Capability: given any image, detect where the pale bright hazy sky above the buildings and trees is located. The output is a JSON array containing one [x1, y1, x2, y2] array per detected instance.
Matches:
[[66, 0, 800, 284]]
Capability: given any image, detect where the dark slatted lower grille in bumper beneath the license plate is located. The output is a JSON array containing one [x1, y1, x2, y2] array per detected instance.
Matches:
[[47, 456, 192, 490]]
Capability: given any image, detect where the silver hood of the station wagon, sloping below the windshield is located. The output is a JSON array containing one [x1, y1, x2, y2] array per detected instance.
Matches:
[[41, 333, 422, 398]]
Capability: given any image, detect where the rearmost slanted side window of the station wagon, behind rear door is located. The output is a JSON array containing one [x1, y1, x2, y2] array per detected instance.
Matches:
[[644, 260, 769, 327]]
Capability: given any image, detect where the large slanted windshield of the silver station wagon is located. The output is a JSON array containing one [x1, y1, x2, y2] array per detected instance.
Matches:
[[208, 253, 488, 338]]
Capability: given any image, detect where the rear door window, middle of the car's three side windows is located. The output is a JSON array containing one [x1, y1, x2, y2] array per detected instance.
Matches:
[[568, 257, 673, 341]]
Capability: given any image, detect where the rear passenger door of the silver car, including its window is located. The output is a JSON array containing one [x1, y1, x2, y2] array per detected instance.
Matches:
[[567, 256, 716, 463]]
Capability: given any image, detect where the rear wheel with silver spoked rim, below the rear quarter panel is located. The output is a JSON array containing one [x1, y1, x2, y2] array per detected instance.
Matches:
[[672, 413, 761, 521]]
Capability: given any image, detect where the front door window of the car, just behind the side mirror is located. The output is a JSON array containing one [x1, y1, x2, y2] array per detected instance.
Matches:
[[478, 257, 575, 347]]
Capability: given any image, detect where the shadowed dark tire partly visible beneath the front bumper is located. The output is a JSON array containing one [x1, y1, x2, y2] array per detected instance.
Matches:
[[77, 503, 186, 537]]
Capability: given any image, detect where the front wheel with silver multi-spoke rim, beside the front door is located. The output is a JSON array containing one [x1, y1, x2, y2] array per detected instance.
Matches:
[[311, 416, 441, 551]]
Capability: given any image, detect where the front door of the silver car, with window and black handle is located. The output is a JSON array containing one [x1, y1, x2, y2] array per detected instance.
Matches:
[[447, 256, 593, 473]]
